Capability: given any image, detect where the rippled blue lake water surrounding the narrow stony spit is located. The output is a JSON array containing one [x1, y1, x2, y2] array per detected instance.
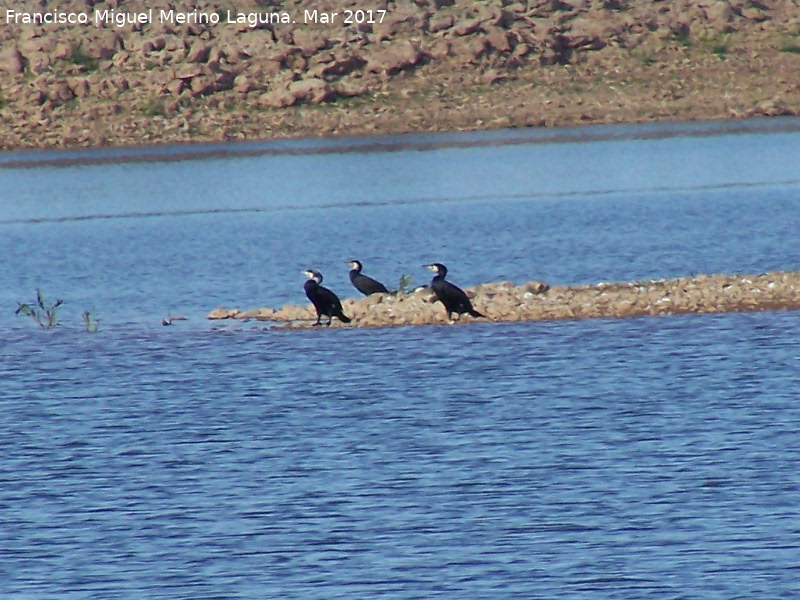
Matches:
[[0, 119, 800, 600]]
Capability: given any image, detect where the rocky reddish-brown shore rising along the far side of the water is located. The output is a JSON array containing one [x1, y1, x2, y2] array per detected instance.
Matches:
[[0, 0, 800, 150]]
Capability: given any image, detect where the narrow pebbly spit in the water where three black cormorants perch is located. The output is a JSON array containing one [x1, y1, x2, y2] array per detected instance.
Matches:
[[208, 271, 800, 329]]
